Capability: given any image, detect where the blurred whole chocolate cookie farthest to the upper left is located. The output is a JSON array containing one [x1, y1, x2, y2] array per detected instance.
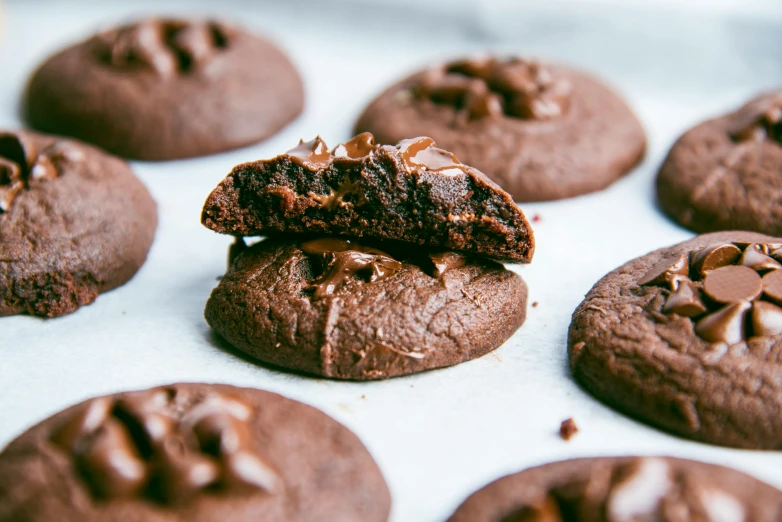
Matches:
[[25, 19, 303, 160]]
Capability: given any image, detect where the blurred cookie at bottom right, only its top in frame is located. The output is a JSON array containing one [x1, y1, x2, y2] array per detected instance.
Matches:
[[449, 457, 782, 522]]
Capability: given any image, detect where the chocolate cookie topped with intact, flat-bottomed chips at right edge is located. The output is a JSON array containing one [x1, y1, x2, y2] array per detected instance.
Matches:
[[568, 232, 782, 450]]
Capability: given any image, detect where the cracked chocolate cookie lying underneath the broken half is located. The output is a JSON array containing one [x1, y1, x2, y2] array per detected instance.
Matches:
[[206, 238, 527, 380]]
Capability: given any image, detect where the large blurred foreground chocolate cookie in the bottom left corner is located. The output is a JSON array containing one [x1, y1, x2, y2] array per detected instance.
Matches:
[[0, 384, 390, 522]]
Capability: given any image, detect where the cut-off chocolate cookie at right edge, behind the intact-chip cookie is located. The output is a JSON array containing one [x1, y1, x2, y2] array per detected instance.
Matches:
[[657, 91, 782, 236]]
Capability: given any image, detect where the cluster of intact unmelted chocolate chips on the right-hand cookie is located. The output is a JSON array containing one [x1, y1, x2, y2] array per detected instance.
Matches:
[[638, 243, 782, 344]]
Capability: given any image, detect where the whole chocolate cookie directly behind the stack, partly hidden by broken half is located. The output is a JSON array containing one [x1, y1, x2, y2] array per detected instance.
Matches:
[[356, 57, 646, 201]]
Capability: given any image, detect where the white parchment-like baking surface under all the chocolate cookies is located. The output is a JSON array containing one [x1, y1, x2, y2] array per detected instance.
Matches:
[[0, 0, 782, 522]]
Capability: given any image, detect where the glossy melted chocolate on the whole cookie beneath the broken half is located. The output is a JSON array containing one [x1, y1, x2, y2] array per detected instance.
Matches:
[[300, 238, 403, 298]]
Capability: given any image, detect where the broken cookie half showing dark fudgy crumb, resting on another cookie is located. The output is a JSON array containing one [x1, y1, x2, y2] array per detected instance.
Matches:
[[201, 133, 535, 263]]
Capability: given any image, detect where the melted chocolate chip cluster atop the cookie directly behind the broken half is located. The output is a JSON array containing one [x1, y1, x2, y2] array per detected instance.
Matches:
[[414, 58, 572, 120]]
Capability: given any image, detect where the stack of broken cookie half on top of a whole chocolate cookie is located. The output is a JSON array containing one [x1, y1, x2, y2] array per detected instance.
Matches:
[[202, 133, 534, 380]]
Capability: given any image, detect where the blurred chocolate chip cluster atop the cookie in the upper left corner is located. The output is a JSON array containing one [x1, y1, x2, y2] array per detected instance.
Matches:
[[95, 20, 229, 78]]
